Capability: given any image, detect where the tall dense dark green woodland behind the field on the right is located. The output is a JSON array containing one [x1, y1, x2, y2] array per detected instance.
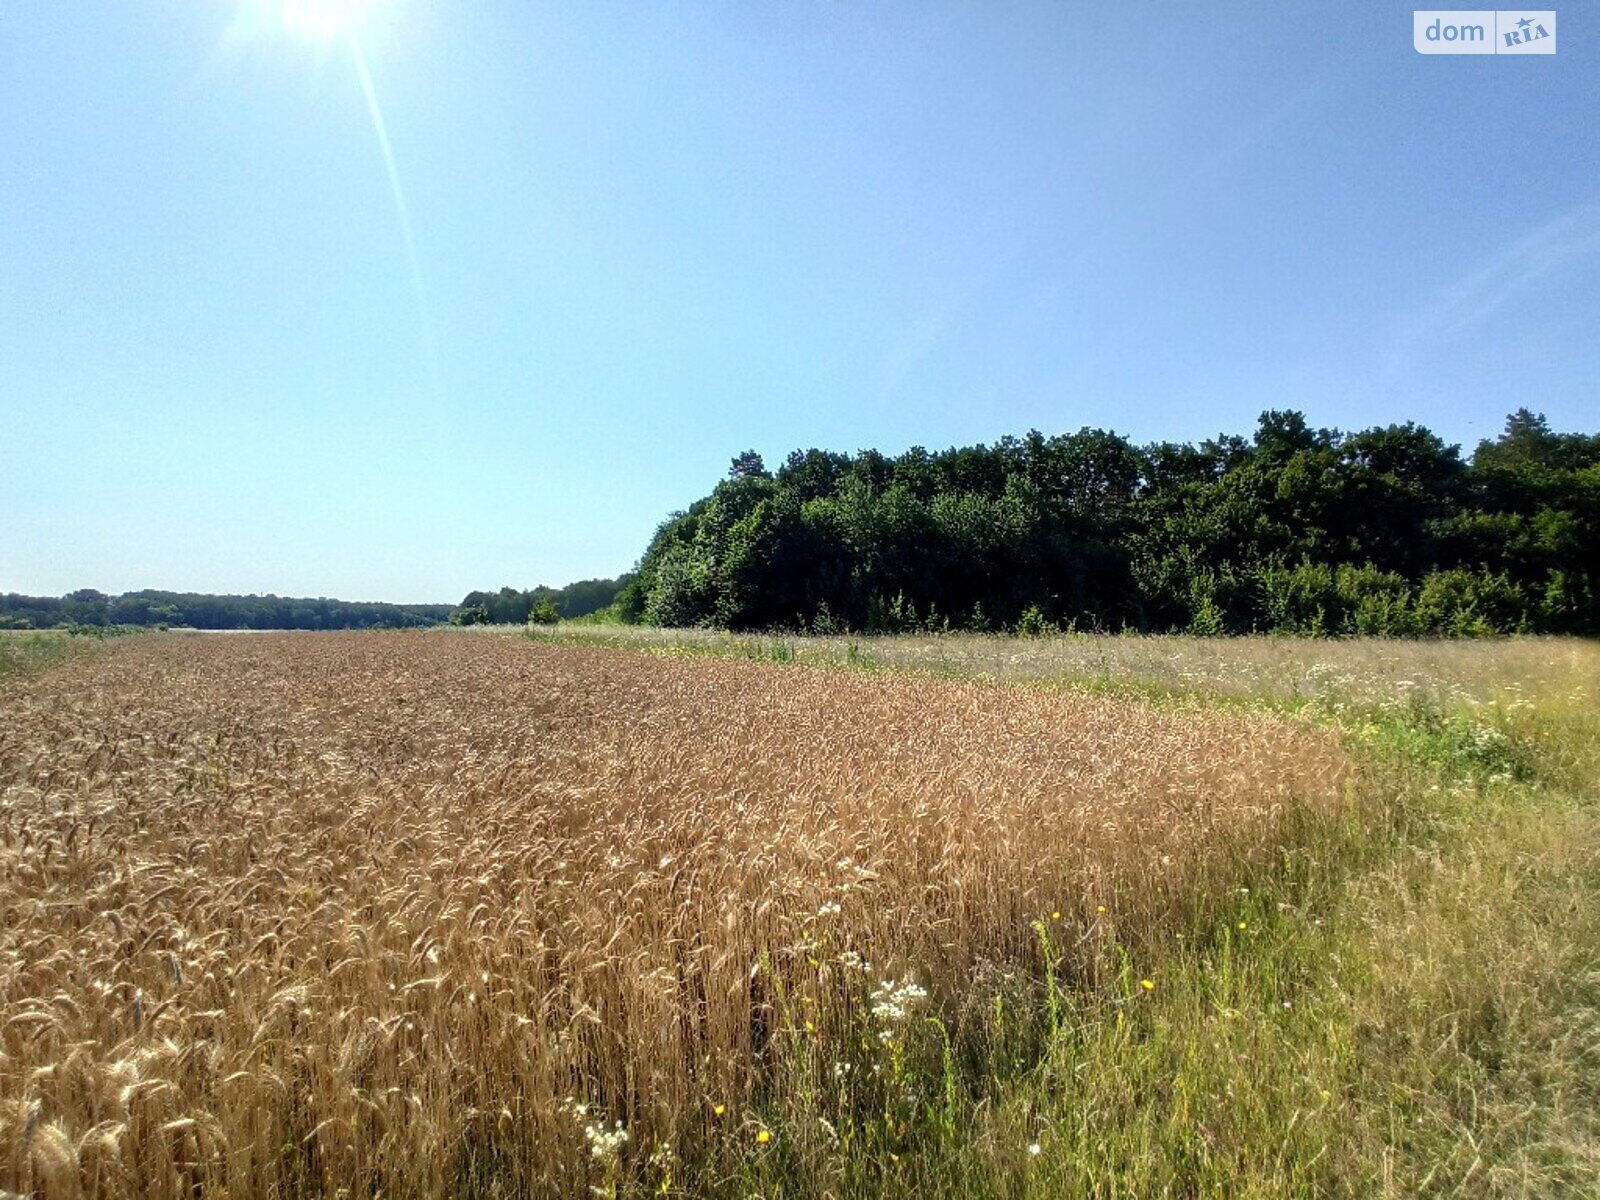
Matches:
[[618, 410, 1600, 634]]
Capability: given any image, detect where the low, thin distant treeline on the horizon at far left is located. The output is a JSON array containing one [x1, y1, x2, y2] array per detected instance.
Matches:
[[0, 587, 451, 629]]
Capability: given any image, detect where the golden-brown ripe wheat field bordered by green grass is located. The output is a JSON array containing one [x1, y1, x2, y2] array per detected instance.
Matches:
[[0, 634, 1352, 1198]]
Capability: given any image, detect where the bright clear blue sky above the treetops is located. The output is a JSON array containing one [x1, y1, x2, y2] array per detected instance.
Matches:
[[0, 0, 1600, 600]]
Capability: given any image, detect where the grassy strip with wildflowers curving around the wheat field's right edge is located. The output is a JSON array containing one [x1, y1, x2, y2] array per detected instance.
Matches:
[[524, 629, 1600, 1197]]
